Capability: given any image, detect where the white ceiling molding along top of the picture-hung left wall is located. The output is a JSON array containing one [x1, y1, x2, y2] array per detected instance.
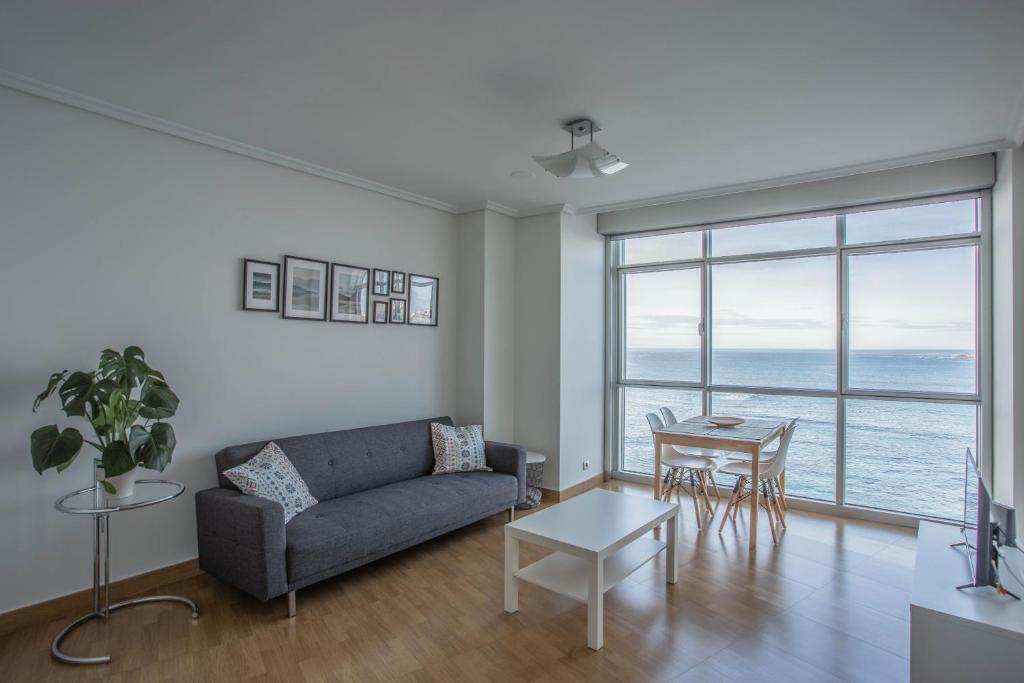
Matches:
[[0, 69, 460, 213]]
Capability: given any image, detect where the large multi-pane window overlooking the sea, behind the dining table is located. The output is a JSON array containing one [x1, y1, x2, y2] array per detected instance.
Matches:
[[609, 196, 984, 519]]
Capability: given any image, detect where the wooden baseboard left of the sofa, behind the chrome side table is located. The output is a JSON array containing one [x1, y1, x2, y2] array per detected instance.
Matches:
[[0, 558, 203, 636]]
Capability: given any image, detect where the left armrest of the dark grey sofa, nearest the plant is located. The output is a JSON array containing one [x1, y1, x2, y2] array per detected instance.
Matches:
[[196, 488, 288, 601]]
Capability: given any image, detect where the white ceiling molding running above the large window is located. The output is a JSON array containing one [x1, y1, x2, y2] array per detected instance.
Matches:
[[578, 139, 1016, 214]]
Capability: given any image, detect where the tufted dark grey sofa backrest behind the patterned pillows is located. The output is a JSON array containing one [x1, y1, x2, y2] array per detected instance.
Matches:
[[216, 418, 452, 502]]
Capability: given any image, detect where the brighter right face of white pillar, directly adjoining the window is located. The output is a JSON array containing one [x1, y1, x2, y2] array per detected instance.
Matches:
[[558, 214, 605, 488]]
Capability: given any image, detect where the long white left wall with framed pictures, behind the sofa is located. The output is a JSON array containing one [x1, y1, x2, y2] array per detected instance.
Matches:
[[0, 88, 457, 611]]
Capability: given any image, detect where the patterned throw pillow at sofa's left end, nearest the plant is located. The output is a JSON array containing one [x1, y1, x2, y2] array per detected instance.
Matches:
[[224, 441, 316, 524]]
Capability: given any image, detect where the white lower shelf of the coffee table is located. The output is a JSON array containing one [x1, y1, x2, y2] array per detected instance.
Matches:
[[515, 537, 666, 602]]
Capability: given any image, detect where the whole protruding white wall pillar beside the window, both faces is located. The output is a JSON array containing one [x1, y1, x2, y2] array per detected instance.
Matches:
[[515, 213, 605, 490]]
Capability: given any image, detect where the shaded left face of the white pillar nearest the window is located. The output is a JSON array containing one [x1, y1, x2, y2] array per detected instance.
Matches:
[[515, 213, 561, 490]]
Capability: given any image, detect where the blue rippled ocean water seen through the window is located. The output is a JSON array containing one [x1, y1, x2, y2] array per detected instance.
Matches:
[[623, 349, 978, 519]]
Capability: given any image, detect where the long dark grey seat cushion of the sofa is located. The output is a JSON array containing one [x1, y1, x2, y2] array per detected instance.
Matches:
[[286, 472, 518, 584]]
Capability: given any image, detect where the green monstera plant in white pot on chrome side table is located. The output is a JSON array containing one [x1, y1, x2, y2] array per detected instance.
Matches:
[[32, 346, 178, 498]]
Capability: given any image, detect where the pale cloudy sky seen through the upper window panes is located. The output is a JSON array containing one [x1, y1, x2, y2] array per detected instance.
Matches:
[[626, 200, 976, 350]]
